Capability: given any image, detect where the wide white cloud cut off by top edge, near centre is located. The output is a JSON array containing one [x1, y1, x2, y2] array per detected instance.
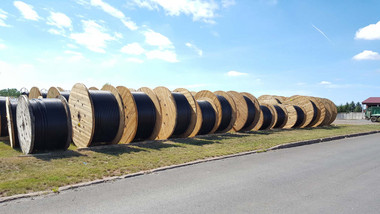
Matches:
[[134, 0, 219, 24]]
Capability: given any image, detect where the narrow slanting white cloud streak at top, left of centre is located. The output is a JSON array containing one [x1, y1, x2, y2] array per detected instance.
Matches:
[[91, 0, 138, 30]]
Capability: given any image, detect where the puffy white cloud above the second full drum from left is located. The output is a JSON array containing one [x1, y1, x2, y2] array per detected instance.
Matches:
[[70, 20, 116, 53]]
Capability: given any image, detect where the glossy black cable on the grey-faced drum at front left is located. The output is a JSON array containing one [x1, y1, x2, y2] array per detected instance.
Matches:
[[29, 99, 71, 150]]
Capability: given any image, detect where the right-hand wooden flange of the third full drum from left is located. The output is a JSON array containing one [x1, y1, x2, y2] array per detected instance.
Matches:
[[138, 87, 162, 140]]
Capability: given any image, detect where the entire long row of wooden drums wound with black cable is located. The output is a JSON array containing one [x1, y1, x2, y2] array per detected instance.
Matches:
[[0, 83, 337, 154]]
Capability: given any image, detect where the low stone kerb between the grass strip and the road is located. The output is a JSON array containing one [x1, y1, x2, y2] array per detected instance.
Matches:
[[0, 131, 380, 204]]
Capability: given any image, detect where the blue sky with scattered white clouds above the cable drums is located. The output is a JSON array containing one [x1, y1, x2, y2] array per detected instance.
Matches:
[[0, 0, 380, 104]]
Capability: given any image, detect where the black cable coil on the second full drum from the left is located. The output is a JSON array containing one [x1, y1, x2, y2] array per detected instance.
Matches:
[[89, 90, 120, 145]]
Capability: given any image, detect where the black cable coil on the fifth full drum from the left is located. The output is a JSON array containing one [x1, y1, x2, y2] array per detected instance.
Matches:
[[197, 100, 216, 135]]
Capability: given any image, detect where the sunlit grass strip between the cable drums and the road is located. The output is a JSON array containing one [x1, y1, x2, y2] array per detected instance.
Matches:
[[0, 124, 380, 196]]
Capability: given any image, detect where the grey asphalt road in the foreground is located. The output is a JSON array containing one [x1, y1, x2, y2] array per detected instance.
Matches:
[[0, 134, 380, 214]]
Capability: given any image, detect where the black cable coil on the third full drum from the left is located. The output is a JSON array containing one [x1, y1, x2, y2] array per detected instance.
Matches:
[[132, 92, 156, 141]]
